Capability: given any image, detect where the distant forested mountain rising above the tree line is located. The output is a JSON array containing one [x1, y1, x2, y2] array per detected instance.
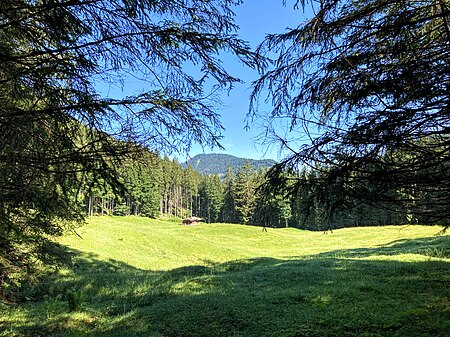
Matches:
[[182, 153, 276, 174]]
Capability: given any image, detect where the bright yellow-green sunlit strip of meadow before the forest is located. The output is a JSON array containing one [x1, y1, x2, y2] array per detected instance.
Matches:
[[60, 217, 448, 270]]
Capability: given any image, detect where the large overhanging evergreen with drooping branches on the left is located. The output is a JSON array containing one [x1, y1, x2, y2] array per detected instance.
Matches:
[[0, 0, 255, 295]]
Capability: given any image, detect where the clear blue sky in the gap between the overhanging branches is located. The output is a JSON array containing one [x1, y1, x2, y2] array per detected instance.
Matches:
[[184, 0, 307, 161]]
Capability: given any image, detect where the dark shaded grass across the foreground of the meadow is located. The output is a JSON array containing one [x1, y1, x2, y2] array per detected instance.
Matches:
[[0, 237, 450, 336]]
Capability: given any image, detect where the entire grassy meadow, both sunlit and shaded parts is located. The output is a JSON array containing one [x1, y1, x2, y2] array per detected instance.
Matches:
[[0, 217, 450, 336]]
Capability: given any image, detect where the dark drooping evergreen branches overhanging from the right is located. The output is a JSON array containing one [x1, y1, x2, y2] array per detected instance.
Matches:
[[251, 0, 450, 226]]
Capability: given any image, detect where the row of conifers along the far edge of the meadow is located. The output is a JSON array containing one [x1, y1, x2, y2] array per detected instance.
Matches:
[[84, 149, 418, 230]]
